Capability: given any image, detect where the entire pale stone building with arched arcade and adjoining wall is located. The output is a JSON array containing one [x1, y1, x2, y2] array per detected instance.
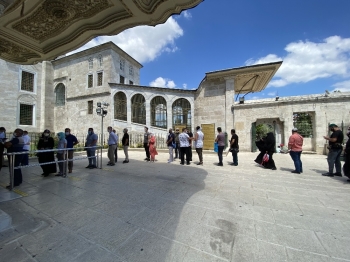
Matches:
[[0, 42, 350, 154]]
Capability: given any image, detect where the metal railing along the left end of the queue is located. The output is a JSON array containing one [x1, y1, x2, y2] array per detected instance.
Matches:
[[4, 146, 102, 190]]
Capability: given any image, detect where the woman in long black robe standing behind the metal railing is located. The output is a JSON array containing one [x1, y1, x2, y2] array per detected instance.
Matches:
[[37, 129, 57, 177]]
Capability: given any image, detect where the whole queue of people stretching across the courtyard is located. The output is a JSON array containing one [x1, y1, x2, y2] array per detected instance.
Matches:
[[0, 124, 350, 190]]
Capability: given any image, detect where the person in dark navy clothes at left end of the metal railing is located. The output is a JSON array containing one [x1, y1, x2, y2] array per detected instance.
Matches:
[[4, 128, 24, 189]]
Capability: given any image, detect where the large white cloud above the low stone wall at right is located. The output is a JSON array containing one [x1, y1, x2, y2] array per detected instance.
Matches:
[[246, 36, 350, 87]]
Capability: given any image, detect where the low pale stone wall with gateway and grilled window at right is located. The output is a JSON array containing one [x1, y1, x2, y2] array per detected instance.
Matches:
[[234, 93, 350, 154]]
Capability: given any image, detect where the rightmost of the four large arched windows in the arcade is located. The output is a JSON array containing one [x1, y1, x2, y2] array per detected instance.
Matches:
[[172, 98, 192, 130]]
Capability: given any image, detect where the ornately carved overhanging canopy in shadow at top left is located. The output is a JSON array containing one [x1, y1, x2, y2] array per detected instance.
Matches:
[[0, 0, 203, 64]]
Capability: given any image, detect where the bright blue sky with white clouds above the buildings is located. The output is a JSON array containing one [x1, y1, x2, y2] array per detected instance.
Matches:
[[69, 0, 350, 99]]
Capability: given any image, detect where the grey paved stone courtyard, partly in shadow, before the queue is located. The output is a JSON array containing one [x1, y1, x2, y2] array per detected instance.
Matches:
[[0, 151, 350, 262]]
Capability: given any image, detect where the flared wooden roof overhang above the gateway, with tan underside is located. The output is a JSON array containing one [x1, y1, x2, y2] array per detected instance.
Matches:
[[206, 61, 282, 94]]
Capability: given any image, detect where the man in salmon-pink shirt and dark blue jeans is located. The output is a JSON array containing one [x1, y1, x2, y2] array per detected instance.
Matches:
[[288, 127, 304, 174]]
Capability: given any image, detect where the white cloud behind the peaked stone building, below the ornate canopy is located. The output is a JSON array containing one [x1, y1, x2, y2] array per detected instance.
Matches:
[[68, 17, 183, 63]]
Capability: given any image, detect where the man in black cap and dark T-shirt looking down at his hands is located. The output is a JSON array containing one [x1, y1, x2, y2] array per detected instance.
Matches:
[[322, 124, 344, 177]]
